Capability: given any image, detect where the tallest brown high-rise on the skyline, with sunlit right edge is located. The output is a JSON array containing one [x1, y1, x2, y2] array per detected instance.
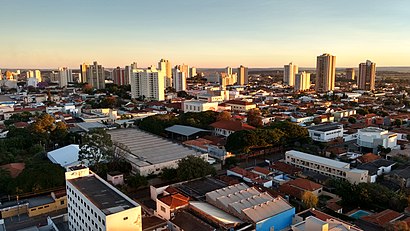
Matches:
[[315, 54, 336, 92]]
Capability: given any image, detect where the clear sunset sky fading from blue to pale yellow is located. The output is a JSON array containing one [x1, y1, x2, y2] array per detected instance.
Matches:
[[0, 0, 410, 69]]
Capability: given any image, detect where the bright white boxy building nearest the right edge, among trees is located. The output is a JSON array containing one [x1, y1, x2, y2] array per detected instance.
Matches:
[[357, 127, 397, 150]]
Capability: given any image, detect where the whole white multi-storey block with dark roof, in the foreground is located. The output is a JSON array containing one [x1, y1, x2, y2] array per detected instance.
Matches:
[[65, 166, 142, 231]]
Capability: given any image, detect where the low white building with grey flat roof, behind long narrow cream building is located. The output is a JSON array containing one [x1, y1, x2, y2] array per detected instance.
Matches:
[[308, 123, 343, 142]]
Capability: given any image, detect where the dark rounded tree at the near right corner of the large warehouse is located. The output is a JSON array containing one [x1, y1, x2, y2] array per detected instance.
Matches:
[[177, 156, 216, 181]]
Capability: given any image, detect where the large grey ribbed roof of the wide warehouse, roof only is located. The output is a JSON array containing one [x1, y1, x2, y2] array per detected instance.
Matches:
[[108, 128, 201, 167]]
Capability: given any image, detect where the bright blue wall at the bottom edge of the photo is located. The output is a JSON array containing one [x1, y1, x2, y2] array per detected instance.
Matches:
[[256, 208, 295, 231]]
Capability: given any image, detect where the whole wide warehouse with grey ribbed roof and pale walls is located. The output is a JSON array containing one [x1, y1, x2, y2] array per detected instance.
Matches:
[[108, 129, 208, 176]]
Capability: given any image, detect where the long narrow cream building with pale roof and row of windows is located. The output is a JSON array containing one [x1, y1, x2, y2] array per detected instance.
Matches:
[[285, 150, 368, 184]]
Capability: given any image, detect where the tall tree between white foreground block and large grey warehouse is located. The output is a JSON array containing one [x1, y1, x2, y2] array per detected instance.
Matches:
[[79, 129, 114, 169]]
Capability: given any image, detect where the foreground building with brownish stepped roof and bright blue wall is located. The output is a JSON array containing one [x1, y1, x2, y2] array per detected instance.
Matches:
[[205, 183, 295, 231]]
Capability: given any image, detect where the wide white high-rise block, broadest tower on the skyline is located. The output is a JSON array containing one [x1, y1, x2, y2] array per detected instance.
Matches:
[[131, 66, 165, 101]]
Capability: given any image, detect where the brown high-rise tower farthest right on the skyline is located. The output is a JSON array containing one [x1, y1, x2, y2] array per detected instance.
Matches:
[[357, 60, 376, 91]]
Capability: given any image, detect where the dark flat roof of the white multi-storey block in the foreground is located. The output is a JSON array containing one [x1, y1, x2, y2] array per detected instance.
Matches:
[[68, 175, 137, 215]]
